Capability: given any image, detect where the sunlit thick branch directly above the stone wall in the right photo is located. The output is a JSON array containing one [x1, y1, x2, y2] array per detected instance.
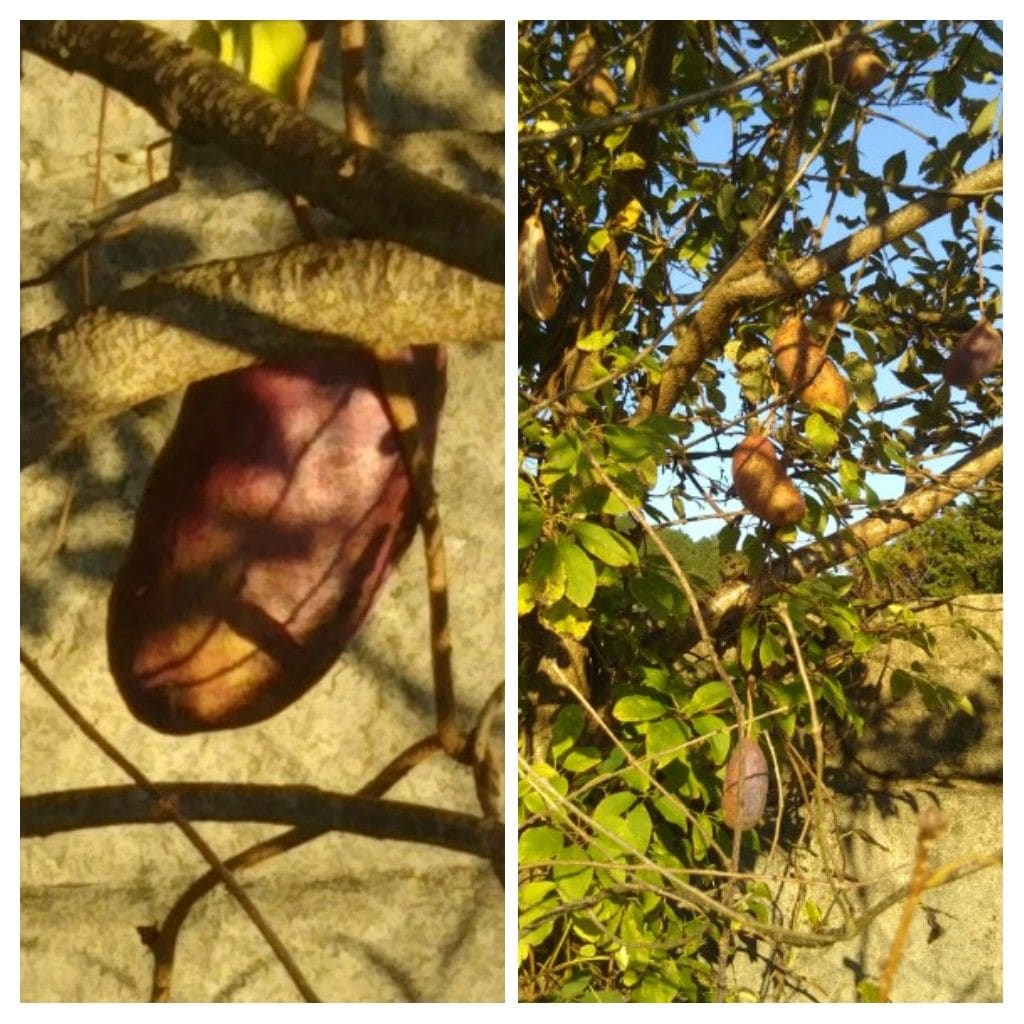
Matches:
[[684, 429, 1002, 647]]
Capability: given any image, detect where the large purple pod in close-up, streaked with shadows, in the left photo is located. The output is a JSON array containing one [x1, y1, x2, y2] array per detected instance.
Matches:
[[106, 348, 444, 733]]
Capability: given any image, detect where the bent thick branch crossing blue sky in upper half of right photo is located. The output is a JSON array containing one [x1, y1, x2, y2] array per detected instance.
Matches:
[[634, 160, 1002, 422]]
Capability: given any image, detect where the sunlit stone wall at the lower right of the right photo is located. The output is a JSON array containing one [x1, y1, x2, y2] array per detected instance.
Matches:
[[736, 594, 1002, 1002]]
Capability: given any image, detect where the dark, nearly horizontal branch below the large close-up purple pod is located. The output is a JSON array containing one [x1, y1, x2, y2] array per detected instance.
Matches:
[[22, 782, 505, 859]]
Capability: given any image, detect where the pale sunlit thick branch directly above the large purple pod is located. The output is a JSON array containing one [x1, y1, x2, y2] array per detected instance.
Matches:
[[22, 241, 504, 465]]
